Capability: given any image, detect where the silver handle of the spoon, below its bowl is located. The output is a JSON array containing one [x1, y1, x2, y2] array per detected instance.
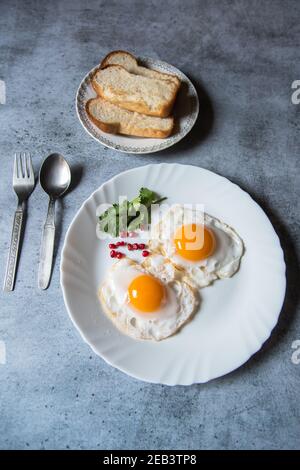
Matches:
[[38, 198, 55, 289]]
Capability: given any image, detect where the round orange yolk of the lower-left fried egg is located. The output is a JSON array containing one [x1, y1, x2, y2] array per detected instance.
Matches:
[[128, 274, 165, 313]]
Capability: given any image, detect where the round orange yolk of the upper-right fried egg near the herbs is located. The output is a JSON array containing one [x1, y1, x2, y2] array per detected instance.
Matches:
[[174, 224, 215, 261]]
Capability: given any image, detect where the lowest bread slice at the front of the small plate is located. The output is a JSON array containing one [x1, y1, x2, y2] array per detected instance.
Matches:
[[86, 97, 174, 139]]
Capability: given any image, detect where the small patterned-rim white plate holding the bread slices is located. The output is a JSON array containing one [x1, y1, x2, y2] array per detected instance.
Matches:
[[76, 58, 199, 153]]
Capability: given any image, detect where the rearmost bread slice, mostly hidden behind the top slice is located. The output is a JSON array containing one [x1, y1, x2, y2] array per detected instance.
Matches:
[[100, 51, 180, 88]]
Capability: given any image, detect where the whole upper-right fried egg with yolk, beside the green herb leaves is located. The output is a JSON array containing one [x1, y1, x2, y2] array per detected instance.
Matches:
[[150, 204, 244, 287]]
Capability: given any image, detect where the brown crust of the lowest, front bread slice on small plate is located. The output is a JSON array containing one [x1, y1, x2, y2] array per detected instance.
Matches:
[[85, 98, 174, 139]]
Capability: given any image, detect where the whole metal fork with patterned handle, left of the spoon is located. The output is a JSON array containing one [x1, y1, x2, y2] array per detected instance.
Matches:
[[3, 152, 34, 291]]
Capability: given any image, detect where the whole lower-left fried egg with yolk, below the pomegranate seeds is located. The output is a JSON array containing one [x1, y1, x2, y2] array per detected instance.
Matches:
[[99, 257, 197, 341]]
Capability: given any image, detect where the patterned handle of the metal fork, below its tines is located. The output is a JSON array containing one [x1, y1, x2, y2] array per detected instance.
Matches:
[[3, 209, 24, 292]]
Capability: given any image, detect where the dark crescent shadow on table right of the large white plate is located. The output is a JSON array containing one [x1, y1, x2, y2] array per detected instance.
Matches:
[[210, 182, 300, 388]]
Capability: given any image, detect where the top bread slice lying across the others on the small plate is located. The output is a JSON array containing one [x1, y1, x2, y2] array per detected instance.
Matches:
[[92, 65, 177, 117]]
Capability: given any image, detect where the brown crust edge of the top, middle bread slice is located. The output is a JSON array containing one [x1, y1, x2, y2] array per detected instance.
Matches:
[[92, 64, 178, 118]]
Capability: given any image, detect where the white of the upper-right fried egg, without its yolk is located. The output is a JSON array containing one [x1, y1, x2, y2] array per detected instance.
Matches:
[[150, 204, 244, 287]]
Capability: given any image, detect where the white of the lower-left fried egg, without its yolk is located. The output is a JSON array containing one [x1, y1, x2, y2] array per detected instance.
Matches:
[[99, 257, 197, 341]]
